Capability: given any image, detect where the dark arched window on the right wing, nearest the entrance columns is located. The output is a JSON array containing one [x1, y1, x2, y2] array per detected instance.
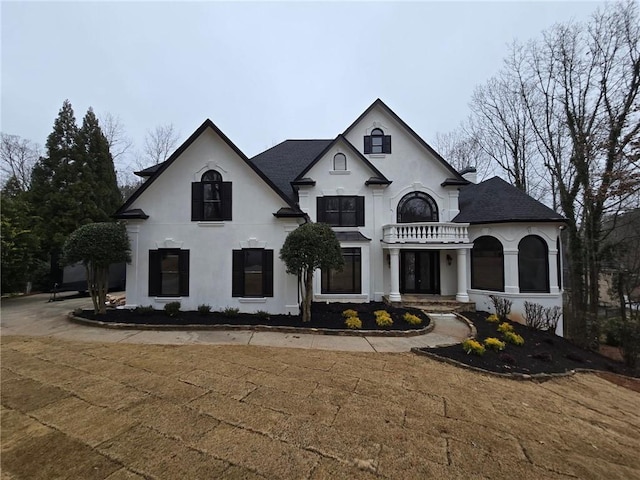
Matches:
[[471, 236, 504, 292]]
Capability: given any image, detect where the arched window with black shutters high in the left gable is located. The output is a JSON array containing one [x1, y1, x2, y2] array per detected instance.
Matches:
[[191, 170, 232, 221]]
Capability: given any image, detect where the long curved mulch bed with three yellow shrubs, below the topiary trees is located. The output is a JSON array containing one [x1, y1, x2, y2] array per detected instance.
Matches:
[[74, 302, 429, 331]]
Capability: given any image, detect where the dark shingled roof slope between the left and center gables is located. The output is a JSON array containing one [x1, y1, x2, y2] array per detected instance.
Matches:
[[251, 140, 333, 202]]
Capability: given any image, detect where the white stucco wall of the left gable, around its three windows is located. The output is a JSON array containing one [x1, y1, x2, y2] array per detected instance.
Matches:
[[127, 130, 298, 313]]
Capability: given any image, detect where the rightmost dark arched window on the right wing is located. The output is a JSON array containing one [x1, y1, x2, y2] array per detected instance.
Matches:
[[518, 235, 549, 292]]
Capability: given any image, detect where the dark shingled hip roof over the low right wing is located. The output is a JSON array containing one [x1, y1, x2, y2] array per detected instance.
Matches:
[[453, 177, 564, 224]]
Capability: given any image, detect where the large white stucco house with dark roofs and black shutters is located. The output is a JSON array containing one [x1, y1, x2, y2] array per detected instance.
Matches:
[[115, 100, 563, 332]]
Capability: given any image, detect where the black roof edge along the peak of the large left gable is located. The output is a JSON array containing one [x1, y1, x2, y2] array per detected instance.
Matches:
[[113, 118, 299, 218]]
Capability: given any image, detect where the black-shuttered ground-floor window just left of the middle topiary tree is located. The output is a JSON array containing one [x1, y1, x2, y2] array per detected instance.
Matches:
[[231, 248, 273, 297]]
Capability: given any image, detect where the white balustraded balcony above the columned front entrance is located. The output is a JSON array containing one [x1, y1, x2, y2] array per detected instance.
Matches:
[[382, 222, 469, 244]]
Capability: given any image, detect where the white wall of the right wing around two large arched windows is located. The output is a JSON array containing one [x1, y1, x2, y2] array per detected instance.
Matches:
[[467, 223, 563, 335]]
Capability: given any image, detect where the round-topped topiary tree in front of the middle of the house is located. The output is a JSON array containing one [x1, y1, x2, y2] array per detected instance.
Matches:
[[280, 223, 344, 322]]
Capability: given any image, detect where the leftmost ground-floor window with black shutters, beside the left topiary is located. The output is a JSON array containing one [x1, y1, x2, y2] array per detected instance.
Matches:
[[149, 248, 189, 297]]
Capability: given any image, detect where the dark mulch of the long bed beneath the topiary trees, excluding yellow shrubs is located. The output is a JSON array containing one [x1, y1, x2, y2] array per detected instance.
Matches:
[[76, 302, 429, 331]]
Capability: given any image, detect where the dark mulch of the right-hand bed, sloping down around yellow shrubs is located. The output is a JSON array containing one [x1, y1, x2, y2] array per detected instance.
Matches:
[[421, 312, 639, 376]]
